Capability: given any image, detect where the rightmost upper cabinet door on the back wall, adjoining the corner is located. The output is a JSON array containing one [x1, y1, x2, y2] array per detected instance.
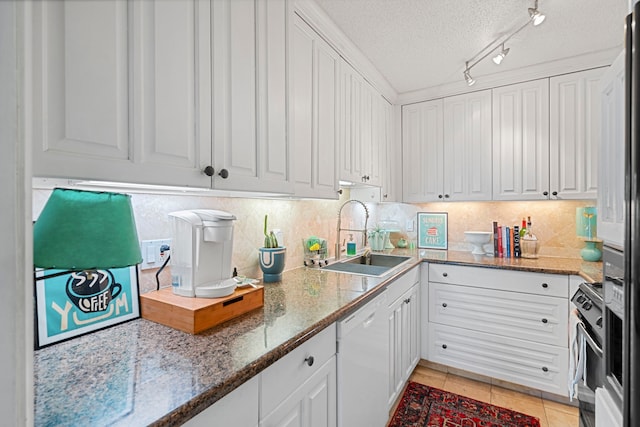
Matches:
[[549, 68, 605, 199]]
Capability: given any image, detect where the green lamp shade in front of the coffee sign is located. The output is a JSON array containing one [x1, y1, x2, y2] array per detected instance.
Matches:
[[33, 188, 142, 270]]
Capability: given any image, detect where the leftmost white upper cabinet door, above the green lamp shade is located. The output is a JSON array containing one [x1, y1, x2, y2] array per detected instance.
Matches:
[[29, 2, 133, 178]]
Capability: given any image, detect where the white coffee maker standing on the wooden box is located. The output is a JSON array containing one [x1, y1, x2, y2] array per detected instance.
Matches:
[[169, 209, 236, 298]]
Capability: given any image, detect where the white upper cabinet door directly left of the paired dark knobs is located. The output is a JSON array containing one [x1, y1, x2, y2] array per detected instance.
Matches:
[[130, 0, 211, 187]]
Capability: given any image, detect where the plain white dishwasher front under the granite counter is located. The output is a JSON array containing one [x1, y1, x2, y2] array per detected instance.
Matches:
[[337, 290, 389, 427]]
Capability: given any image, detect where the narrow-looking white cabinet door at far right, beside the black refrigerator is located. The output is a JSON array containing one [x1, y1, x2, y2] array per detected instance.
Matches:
[[598, 52, 625, 247]]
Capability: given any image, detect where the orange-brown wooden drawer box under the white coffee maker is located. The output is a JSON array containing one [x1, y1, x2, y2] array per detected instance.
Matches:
[[140, 285, 264, 334]]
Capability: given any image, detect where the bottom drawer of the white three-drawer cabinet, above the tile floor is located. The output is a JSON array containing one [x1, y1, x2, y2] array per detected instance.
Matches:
[[429, 323, 569, 396]]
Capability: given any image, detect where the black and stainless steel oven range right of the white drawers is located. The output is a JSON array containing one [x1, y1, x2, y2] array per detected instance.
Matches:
[[571, 283, 605, 427]]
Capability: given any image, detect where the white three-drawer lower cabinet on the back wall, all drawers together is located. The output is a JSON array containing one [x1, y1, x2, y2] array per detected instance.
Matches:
[[423, 264, 569, 396]]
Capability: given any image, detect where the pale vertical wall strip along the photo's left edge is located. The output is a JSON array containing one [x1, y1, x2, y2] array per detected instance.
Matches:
[[0, 0, 33, 426]]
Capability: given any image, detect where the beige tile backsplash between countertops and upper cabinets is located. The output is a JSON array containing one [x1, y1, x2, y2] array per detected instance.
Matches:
[[33, 189, 595, 292]]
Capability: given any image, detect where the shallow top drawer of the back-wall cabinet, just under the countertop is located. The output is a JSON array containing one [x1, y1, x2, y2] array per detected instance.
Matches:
[[429, 264, 569, 299]]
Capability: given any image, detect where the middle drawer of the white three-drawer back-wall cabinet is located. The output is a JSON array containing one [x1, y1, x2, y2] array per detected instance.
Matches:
[[429, 283, 569, 347]]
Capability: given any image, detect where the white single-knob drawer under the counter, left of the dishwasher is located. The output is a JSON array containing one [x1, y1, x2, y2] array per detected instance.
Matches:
[[260, 324, 336, 414]]
